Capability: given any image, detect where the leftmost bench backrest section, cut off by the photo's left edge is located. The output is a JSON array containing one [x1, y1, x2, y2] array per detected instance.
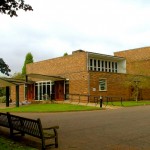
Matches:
[[0, 112, 9, 128]]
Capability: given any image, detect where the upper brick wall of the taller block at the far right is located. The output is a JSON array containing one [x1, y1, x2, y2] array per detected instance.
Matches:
[[114, 47, 150, 76]]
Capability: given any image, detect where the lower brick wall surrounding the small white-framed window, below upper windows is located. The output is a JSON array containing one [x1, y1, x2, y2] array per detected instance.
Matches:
[[90, 72, 129, 99]]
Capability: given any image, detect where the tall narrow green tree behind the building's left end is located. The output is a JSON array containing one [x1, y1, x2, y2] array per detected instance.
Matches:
[[22, 53, 33, 75]]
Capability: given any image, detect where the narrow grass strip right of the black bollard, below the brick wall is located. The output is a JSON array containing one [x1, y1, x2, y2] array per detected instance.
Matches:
[[103, 100, 150, 107]]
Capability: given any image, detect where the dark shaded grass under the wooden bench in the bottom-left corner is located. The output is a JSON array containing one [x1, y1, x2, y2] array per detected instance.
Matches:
[[0, 136, 36, 150]]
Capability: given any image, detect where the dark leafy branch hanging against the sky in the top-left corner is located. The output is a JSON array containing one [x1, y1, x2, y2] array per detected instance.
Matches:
[[0, 0, 33, 17]]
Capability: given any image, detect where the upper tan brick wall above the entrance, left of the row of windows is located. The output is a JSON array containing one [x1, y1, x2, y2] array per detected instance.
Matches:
[[27, 52, 87, 75]]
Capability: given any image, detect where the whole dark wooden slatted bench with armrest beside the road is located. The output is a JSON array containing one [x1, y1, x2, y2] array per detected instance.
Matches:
[[0, 113, 59, 149]]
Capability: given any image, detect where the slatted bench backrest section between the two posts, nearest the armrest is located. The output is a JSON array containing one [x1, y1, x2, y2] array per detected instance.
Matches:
[[10, 114, 43, 137]]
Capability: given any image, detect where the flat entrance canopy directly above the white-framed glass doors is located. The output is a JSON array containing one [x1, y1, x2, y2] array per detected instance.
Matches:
[[26, 73, 66, 81]]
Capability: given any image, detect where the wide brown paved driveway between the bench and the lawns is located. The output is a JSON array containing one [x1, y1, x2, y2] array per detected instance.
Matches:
[[9, 106, 150, 150]]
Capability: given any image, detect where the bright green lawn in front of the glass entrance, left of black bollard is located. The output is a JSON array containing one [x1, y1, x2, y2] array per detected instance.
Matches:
[[0, 104, 99, 112]]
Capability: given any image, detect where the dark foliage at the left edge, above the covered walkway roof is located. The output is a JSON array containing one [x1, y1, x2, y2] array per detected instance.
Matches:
[[0, 58, 11, 76]]
